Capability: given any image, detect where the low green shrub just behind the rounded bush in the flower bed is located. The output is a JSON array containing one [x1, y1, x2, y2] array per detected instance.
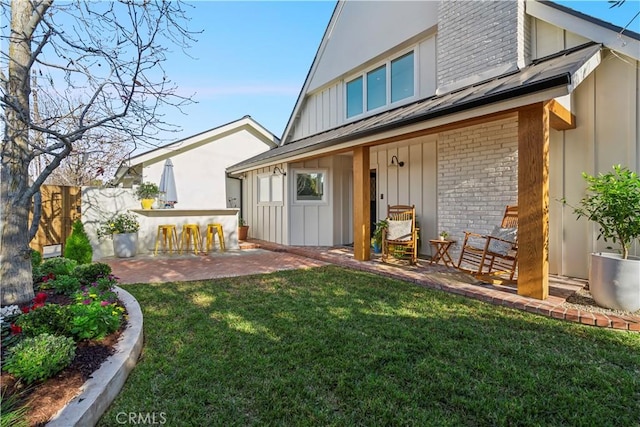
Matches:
[[15, 304, 72, 337]]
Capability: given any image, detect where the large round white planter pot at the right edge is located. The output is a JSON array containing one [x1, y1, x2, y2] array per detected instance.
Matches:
[[589, 252, 640, 311]]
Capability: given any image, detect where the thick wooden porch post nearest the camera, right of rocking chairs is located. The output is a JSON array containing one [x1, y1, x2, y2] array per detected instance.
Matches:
[[518, 103, 549, 299]]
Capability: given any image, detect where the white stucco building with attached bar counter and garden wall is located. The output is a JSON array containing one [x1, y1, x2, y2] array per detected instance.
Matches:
[[82, 116, 279, 259]]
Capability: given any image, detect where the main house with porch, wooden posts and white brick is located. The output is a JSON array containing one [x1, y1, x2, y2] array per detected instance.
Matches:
[[228, 0, 640, 299]]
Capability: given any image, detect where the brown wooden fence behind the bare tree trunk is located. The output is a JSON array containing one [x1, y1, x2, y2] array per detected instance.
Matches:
[[29, 185, 82, 257]]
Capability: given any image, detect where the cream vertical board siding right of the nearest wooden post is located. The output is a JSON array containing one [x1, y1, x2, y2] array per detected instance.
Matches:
[[533, 20, 640, 278]]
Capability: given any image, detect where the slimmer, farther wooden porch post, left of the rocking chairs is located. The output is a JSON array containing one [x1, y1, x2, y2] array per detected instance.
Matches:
[[353, 147, 371, 261]]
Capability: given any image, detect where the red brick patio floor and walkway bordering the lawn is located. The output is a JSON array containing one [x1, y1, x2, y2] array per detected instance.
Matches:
[[102, 240, 640, 331]]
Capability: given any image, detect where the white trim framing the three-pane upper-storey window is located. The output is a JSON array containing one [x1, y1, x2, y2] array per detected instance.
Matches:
[[342, 46, 420, 122]]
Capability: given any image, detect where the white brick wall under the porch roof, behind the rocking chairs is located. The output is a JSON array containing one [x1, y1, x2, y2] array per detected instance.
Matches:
[[438, 118, 518, 261]]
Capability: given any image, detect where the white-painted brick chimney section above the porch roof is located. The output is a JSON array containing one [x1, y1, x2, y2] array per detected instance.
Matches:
[[438, 0, 525, 87]]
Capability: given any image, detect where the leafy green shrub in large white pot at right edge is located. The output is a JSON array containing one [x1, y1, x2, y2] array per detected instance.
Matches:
[[574, 165, 640, 312]]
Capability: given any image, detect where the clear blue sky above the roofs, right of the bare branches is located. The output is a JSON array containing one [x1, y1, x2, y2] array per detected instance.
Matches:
[[152, 0, 640, 145]]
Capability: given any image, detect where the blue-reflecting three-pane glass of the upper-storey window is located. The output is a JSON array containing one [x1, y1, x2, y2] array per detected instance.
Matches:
[[346, 51, 415, 118]]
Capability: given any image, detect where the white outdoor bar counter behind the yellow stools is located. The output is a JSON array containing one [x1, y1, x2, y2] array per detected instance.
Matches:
[[130, 208, 239, 254]]
